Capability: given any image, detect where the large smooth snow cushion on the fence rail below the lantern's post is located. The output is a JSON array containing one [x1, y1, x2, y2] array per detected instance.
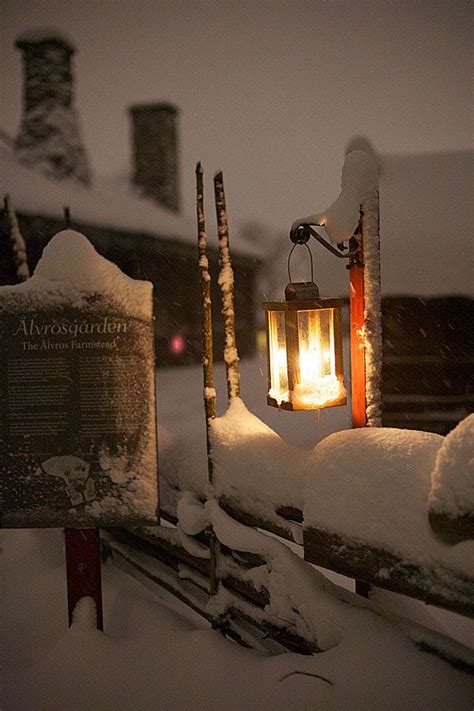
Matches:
[[304, 427, 474, 576]]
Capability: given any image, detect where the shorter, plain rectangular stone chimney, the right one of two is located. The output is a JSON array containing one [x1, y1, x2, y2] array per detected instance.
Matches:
[[129, 103, 180, 212]]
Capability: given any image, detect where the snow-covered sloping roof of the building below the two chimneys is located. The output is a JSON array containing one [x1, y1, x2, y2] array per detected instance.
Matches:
[[0, 145, 262, 257]]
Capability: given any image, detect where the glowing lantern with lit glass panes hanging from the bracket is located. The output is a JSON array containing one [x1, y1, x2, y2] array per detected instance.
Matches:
[[263, 281, 347, 410]]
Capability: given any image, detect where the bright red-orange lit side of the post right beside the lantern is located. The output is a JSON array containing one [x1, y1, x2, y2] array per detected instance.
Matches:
[[349, 236, 367, 427]]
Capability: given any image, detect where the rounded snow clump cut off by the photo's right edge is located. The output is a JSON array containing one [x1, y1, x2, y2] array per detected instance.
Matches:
[[429, 414, 474, 518]]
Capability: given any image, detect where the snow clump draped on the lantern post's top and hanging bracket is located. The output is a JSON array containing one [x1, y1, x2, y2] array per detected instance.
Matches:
[[292, 150, 378, 243]]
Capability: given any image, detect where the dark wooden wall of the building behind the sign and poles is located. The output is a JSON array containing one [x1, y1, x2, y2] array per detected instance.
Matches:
[[0, 214, 259, 366]]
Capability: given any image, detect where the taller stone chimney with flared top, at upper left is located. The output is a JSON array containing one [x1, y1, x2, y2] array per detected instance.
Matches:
[[15, 30, 90, 185]]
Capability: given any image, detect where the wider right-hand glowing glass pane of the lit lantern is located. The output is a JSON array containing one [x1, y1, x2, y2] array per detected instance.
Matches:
[[292, 309, 345, 407]]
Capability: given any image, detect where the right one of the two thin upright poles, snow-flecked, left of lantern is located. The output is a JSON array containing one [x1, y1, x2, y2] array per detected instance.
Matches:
[[214, 171, 240, 401]]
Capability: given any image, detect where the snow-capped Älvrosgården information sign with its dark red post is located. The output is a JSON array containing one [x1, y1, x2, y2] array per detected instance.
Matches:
[[0, 230, 158, 629]]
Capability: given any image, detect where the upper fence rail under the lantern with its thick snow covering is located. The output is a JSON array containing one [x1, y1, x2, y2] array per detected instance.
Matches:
[[119, 412, 474, 616]]
